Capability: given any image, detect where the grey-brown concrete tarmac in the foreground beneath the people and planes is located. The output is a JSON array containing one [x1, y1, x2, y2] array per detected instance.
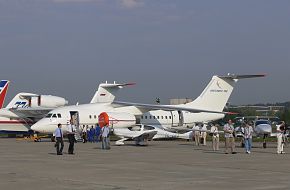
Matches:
[[0, 138, 290, 190]]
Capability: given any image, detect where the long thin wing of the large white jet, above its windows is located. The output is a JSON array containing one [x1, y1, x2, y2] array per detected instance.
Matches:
[[113, 101, 235, 114]]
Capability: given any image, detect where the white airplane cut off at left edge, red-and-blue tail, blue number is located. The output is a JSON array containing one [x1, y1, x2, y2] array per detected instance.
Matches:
[[0, 80, 67, 134]]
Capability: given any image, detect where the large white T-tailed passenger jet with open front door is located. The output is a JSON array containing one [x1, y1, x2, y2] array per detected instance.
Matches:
[[31, 75, 265, 134]]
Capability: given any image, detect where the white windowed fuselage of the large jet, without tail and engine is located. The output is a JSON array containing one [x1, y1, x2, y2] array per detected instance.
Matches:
[[31, 103, 224, 134]]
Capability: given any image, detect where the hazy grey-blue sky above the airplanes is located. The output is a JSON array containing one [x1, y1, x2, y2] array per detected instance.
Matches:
[[0, 0, 290, 105]]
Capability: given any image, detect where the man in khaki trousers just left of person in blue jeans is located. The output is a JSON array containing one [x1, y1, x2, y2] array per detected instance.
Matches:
[[224, 120, 236, 154]]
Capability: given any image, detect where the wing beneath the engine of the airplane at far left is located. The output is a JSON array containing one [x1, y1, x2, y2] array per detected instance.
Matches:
[[9, 107, 53, 118]]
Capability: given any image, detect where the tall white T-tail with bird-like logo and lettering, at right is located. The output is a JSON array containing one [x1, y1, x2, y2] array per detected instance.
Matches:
[[186, 74, 265, 112]]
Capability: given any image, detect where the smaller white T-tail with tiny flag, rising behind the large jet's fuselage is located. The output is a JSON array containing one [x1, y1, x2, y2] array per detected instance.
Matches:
[[90, 82, 135, 103]]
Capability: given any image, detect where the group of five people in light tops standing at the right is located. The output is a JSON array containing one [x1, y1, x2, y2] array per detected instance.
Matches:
[[192, 120, 286, 154]]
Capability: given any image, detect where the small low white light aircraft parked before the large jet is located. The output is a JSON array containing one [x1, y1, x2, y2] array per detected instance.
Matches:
[[113, 125, 192, 145]]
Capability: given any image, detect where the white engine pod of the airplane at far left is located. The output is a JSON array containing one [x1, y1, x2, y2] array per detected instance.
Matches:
[[28, 95, 68, 108]]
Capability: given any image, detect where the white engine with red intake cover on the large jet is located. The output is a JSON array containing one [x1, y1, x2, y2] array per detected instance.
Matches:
[[99, 112, 136, 128]]
